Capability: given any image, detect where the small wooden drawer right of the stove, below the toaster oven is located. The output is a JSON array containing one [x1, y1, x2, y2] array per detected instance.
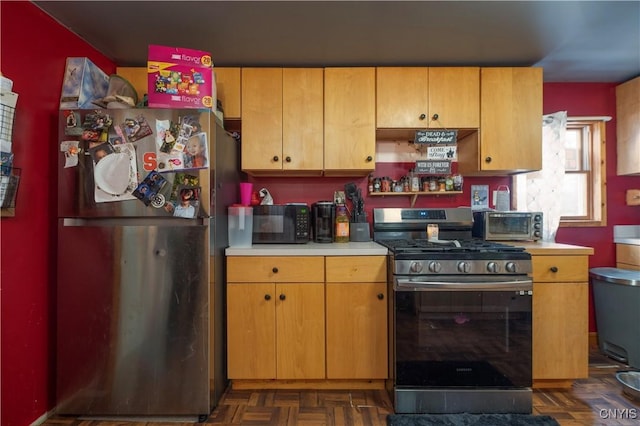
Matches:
[[532, 256, 589, 282]]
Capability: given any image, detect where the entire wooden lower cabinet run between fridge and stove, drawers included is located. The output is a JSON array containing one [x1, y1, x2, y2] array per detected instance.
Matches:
[[227, 256, 388, 388]]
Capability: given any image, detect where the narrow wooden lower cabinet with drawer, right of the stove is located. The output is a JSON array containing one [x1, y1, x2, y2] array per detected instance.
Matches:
[[532, 255, 589, 387]]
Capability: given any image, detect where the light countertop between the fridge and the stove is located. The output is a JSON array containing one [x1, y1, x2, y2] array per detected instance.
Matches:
[[225, 241, 387, 256]]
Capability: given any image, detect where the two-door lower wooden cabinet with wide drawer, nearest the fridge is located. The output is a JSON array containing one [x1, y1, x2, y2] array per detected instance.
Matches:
[[227, 256, 325, 379]]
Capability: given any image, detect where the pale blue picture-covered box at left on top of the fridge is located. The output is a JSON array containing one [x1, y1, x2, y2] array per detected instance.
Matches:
[[60, 58, 109, 109]]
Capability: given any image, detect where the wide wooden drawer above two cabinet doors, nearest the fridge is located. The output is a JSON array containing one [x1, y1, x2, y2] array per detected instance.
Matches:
[[227, 256, 324, 283]]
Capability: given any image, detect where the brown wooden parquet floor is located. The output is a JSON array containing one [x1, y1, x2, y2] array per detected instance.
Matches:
[[43, 347, 640, 426]]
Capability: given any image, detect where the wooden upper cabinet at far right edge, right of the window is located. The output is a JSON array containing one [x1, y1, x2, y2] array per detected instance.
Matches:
[[616, 77, 640, 175]]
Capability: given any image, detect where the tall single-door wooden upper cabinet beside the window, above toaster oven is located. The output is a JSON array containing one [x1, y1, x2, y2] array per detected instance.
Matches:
[[458, 67, 542, 175]]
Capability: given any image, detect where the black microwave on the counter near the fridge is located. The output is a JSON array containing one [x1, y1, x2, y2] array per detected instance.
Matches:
[[252, 204, 310, 244]]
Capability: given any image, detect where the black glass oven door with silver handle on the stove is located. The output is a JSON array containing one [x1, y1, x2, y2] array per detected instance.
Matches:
[[394, 276, 533, 389]]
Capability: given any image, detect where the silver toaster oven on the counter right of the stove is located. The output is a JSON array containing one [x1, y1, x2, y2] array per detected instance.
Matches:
[[472, 210, 542, 241]]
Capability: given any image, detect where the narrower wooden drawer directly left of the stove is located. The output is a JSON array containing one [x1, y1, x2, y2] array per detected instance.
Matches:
[[326, 256, 387, 283]]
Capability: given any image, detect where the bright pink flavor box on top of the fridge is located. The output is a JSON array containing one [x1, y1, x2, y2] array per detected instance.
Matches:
[[147, 45, 216, 109]]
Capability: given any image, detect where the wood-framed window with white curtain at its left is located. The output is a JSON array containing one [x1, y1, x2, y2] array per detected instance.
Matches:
[[513, 113, 610, 232]]
